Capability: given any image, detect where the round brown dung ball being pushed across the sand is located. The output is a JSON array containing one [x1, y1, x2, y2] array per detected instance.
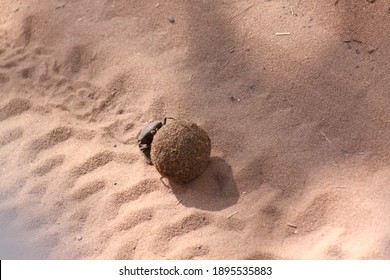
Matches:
[[151, 120, 211, 183]]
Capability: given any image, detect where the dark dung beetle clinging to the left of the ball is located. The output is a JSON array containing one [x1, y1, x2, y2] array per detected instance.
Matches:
[[138, 117, 175, 165]]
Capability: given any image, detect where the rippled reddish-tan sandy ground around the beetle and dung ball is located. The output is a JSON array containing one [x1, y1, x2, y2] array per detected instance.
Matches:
[[0, 0, 390, 259]]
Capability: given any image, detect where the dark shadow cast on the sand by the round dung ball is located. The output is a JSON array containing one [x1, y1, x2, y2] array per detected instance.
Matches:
[[162, 156, 239, 211]]
